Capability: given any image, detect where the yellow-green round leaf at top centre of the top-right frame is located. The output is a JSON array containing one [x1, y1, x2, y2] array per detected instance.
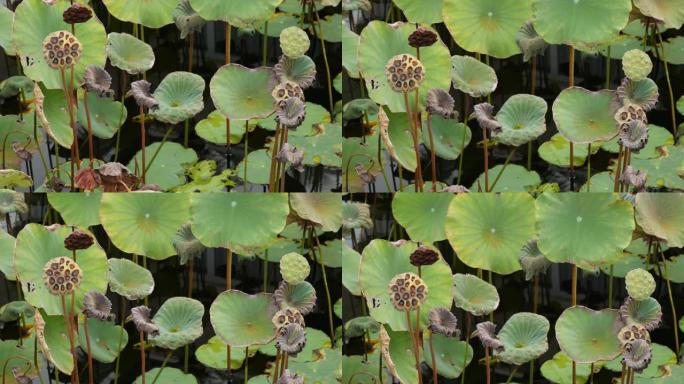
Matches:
[[444, 0, 532, 59]]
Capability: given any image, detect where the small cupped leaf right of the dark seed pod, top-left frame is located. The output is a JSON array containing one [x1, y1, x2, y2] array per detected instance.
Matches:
[[107, 32, 155, 75]]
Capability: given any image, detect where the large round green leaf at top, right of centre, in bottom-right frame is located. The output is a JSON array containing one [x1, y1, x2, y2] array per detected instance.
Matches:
[[537, 193, 635, 265]]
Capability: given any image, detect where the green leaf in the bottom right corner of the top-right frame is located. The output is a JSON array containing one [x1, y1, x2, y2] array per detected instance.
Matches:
[[631, 145, 684, 189]]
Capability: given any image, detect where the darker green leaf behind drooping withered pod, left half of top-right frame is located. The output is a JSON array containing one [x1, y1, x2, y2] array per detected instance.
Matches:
[[422, 115, 472, 160]]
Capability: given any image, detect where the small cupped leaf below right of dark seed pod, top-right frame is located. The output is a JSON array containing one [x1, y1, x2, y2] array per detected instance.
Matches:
[[451, 55, 499, 97]]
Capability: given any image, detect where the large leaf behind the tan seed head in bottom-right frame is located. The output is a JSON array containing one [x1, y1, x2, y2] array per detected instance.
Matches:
[[359, 239, 452, 331]]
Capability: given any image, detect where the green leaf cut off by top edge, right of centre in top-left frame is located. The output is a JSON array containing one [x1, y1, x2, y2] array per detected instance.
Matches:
[[190, 0, 280, 25]]
